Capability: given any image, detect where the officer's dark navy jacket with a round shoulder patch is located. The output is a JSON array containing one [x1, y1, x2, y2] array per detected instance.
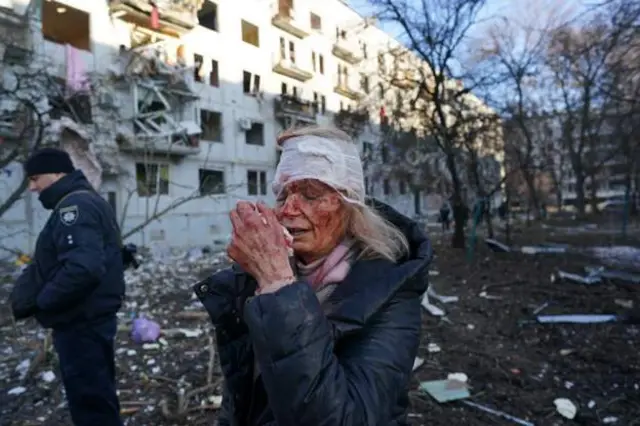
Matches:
[[26, 170, 125, 328]]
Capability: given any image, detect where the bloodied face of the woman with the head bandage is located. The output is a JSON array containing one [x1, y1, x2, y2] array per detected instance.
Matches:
[[275, 179, 347, 263]]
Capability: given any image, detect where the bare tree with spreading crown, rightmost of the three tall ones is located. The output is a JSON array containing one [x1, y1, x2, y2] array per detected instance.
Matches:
[[547, 4, 638, 214]]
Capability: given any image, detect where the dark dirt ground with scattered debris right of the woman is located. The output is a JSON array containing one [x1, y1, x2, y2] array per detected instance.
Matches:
[[412, 230, 640, 426]]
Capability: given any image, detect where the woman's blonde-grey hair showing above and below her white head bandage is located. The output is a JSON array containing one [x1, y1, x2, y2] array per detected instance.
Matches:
[[277, 126, 409, 262]]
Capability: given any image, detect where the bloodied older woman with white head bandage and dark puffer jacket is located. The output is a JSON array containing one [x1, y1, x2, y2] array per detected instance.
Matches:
[[194, 128, 431, 426]]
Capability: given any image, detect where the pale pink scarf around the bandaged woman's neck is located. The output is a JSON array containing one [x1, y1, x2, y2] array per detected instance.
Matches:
[[297, 241, 353, 290]]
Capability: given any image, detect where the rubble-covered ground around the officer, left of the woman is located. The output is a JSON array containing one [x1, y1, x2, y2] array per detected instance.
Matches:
[[0, 248, 227, 426]]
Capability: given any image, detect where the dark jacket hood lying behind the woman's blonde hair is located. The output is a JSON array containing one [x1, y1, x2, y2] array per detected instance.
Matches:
[[367, 198, 433, 263]]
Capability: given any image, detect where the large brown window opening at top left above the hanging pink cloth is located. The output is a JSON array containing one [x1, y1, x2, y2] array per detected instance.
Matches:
[[42, 1, 91, 52]]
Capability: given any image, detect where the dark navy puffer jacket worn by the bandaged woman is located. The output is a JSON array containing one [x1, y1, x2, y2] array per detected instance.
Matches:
[[194, 203, 432, 426]]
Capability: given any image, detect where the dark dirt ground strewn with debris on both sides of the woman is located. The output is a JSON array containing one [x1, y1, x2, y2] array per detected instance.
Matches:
[[0, 221, 640, 426]]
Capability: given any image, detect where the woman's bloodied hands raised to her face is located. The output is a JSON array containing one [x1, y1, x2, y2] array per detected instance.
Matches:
[[227, 201, 293, 289]]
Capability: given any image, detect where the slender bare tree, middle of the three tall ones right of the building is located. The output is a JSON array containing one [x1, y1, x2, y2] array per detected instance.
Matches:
[[481, 0, 569, 218]]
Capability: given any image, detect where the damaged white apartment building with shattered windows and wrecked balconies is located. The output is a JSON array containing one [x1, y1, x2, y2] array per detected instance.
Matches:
[[0, 0, 500, 250]]
